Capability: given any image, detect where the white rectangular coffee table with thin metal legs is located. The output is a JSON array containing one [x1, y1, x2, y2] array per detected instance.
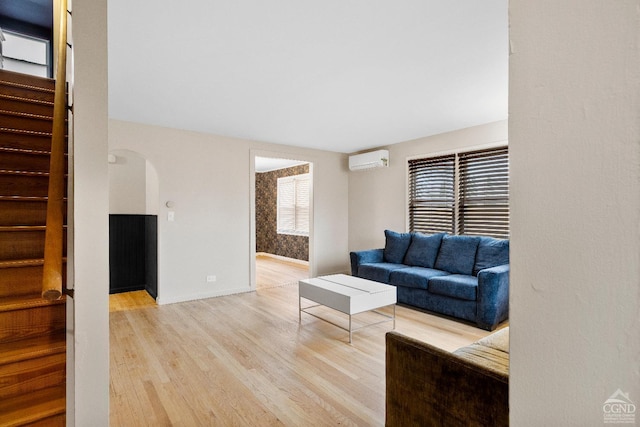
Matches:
[[298, 274, 397, 342]]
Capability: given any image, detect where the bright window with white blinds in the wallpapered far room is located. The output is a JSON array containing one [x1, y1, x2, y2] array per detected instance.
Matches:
[[278, 174, 309, 236]]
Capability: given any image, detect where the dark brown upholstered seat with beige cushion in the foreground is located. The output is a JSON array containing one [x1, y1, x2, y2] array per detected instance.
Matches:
[[386, 328, 509, 427]]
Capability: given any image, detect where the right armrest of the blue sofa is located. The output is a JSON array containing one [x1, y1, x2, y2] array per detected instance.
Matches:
[[476, 264, 509, 331]]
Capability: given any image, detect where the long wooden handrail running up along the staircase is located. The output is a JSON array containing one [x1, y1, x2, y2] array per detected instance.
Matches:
[[42, 0, 68, 300]]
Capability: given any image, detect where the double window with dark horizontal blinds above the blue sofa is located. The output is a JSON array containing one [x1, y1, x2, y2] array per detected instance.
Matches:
[[409, 147, 509, 238]]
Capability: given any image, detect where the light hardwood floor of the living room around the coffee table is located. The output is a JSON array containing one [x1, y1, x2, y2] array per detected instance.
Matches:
[[110, 274, 504, 426]]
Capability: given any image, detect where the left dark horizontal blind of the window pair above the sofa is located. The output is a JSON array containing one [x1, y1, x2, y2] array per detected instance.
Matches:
[[409, 155, 455, 234]]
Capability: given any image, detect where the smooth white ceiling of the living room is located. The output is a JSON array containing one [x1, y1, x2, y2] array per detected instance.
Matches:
[[108, 0, 508, 153]]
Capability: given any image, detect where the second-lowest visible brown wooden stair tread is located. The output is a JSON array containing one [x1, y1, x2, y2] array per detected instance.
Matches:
[[0, 332, 66, 365]]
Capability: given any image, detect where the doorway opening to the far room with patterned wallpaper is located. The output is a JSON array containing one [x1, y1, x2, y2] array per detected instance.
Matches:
[[251, 156, 313, 290]]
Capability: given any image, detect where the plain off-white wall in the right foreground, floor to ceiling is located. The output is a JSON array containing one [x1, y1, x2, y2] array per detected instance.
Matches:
[[509, 0, 640, 426]]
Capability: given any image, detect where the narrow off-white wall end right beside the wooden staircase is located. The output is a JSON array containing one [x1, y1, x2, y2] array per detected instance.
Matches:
[[67, 0, 109, 426]]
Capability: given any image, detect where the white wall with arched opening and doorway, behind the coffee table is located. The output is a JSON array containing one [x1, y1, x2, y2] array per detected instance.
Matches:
[[109, 120, 349, 304]]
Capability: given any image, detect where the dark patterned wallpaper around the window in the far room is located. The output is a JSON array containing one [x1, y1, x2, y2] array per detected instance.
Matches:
[[256, 164, 309, 261]]
